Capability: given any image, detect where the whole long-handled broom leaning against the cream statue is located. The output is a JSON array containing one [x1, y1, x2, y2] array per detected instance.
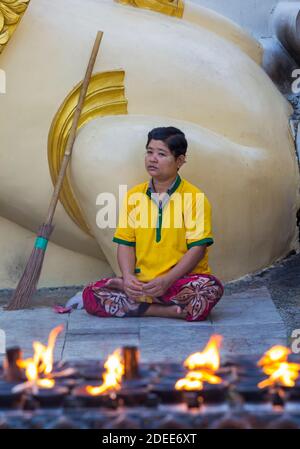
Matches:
[[5, 31, 103, 310]]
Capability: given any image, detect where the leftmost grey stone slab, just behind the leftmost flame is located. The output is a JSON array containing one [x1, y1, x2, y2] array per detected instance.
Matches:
[[0, 308, 68, 360]]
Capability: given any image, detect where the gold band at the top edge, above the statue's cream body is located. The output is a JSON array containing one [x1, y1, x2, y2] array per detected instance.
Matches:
[[115, 0, 184, 19]]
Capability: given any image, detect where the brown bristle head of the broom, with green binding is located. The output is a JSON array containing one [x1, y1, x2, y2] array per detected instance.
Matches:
[[5, 224, 54, 310]]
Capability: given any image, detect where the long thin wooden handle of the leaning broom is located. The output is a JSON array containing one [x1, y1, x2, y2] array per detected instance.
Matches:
[[46, 31, 103, 224]]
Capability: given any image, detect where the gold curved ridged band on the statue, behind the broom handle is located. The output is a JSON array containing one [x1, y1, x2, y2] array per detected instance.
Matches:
[[48, 70, 127, 236]]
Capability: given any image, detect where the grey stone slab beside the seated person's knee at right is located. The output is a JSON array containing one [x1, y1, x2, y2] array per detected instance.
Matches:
[[210, 287, 282, 326]]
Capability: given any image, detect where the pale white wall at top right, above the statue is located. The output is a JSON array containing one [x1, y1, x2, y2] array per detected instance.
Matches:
[[192, 0, 300, 38]]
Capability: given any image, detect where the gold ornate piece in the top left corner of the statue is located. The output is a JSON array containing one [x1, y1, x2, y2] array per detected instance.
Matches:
[[0, 0, 30, 54]]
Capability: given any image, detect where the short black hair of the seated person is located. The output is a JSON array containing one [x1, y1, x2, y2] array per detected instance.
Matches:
[[146, 126, 187, 158]]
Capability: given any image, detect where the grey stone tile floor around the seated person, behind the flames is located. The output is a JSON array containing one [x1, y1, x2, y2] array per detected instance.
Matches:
[[0, 254, 300, 361]]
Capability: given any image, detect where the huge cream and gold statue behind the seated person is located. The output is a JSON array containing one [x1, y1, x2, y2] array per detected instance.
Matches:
[[0, 0, 300, 288]]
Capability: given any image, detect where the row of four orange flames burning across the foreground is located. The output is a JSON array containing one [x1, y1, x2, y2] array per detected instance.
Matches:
[[11, 325, 300, 396]]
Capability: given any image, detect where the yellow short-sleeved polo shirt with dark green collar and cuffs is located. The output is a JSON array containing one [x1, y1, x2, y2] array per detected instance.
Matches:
[[113, 175, 213, 282]]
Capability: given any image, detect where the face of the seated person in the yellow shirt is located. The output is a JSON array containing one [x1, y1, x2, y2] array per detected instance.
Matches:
[[145, 139, 184, 181]]
